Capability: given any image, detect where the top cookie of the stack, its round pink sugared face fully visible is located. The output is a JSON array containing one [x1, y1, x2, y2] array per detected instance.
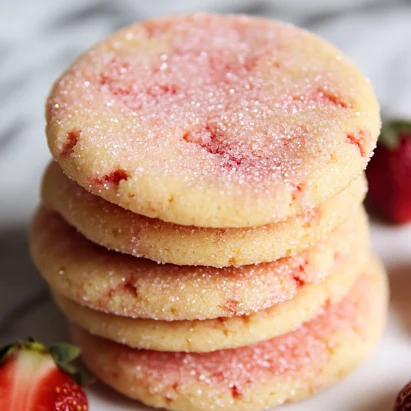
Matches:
[[47, 14, 380, 227]]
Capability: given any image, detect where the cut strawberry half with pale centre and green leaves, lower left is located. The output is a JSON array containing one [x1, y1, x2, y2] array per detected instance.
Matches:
[[0, 339, 89, 411]]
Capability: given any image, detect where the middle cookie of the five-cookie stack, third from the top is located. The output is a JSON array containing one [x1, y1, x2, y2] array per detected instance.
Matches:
[[30, 208, 369, 321]]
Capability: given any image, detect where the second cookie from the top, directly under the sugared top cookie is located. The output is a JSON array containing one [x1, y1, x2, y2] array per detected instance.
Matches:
[[42, 163, 367, 267]]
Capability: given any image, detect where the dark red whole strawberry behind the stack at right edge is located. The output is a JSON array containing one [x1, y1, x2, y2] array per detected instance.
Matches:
[[367, 120, 411, 224]]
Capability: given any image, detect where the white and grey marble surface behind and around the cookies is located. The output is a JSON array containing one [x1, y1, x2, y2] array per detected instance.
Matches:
[[0, 0, 411, 411]]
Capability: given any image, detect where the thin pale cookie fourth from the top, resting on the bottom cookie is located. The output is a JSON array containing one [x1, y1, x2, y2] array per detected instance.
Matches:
[[53, 252, 360, 352]]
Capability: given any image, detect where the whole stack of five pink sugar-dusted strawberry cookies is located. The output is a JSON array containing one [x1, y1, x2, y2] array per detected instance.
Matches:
[[31, 14, 387, 411]]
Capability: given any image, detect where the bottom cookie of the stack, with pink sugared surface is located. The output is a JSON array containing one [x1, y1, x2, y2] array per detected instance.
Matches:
[[71, 259, 388, 411]]
